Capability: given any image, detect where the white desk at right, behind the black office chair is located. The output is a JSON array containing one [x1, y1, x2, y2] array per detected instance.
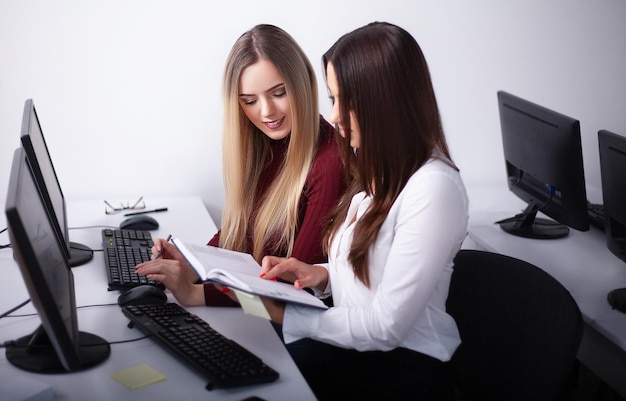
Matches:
[[464, 184, 626, 396]]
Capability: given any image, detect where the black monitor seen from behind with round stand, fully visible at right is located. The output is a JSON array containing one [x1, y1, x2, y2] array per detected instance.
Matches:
[[497, 91, 589, 239]]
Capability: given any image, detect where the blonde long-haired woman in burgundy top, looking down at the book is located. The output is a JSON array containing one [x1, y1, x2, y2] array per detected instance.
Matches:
[[137, 25, 345, 305]]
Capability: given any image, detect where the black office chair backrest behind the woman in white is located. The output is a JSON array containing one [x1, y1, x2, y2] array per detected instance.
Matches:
[[446, 250, 583, 401]]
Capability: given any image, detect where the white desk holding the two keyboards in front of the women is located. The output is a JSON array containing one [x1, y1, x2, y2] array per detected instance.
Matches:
[[0, 198, 315, 401]]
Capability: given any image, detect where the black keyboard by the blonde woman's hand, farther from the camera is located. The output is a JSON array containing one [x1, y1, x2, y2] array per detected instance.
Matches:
[[102, 228, 165, 291]]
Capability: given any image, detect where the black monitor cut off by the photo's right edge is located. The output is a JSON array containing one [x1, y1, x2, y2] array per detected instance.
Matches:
[[598, 130, 626, 262]]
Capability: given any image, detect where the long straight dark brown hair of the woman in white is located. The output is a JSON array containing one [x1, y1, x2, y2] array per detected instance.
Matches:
[[323, 22, 456, 286]]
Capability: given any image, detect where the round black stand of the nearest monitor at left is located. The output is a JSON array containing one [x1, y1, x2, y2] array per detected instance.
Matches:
[[6, 327, 111, 373]]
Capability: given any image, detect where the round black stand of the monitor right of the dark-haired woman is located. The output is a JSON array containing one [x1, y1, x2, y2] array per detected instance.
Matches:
[[496, 203, 569, 239]]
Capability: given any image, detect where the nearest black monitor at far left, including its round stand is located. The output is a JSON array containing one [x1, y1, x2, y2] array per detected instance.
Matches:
[[5, 147, 110, 373]]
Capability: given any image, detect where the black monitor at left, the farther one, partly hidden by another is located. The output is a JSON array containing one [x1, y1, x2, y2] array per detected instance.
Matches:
[[21, 99, 93, 266]]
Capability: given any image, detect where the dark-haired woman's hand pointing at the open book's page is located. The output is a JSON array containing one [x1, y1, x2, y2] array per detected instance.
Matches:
[[261, 256, 328, 291]]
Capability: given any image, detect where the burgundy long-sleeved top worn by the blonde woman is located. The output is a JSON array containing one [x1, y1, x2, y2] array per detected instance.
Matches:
[[204, 116, 345, 306]]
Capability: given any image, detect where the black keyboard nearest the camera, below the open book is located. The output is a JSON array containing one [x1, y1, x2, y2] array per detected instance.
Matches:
[[122, 303, 279, 390]]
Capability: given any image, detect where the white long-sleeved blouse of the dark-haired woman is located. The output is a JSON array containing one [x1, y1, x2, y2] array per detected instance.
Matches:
[[283, 159, 469, 361]]
